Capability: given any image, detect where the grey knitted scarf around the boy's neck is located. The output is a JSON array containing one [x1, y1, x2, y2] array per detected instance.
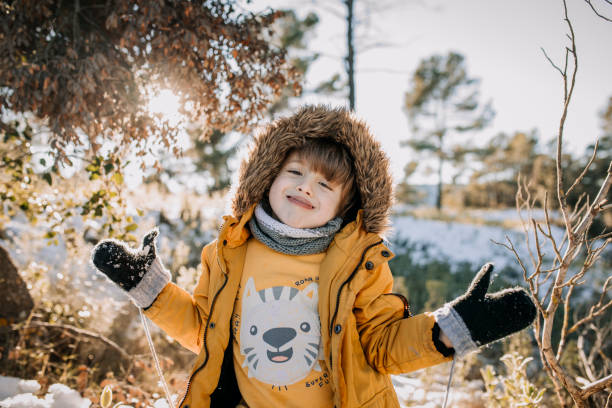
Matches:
[[249, 204, 342, 255]]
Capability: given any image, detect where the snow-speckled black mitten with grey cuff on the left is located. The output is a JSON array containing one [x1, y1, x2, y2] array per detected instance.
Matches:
[[91, 228, 171, 308]]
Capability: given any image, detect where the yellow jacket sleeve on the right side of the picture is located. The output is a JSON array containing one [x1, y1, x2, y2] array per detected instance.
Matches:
[[353, 262, 452, 374]]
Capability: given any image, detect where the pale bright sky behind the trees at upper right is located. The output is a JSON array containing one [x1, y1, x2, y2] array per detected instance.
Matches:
[[249, 0, 612, 183]]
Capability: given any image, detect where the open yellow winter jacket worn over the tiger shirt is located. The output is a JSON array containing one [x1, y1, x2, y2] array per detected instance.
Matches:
[[146, 207, 450, 408]]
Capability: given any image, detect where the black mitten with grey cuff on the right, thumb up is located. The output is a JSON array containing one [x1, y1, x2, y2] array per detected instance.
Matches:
[[434, 263, 536, 356]]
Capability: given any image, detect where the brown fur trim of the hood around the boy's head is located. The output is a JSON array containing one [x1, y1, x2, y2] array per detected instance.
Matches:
[[232, 105, 393, 234]]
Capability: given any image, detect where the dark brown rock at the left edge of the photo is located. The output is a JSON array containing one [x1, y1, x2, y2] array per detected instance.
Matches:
[[0, 246, 34, 327]]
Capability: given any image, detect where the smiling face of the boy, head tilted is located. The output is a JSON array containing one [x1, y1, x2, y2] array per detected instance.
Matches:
[[268, 153, 343, 228]]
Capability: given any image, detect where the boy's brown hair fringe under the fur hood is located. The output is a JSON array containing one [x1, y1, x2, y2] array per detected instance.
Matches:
[[287, 138, 358, 218]]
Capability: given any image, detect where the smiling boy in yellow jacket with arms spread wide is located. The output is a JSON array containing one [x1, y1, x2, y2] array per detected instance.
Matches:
[[93, 106, 535, 408]]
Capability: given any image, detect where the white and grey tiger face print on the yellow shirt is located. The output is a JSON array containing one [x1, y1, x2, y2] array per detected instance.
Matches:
[[240, 278, 321, 386]]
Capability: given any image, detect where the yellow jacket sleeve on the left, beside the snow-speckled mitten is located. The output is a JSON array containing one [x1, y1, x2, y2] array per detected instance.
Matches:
[[145, 240, 217, 353]]
